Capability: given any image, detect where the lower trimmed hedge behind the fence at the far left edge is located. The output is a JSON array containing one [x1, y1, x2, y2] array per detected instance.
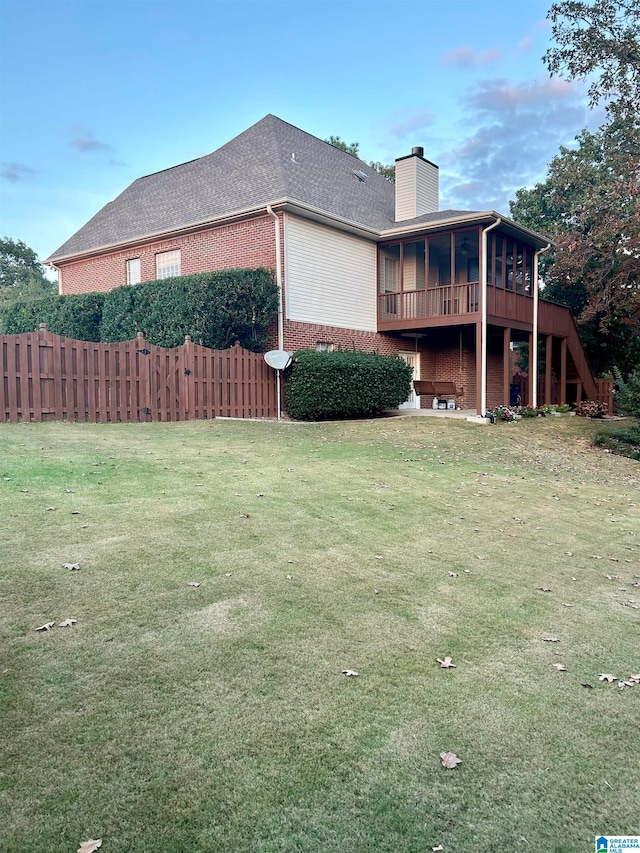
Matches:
[[0, 293, 104, 341]]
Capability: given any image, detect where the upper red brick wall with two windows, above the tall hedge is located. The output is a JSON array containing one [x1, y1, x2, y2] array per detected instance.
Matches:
[[60, 216, 275, 295]]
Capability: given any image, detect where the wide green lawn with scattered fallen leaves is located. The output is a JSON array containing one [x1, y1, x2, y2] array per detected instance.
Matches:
[[0, 418, 640, 853]]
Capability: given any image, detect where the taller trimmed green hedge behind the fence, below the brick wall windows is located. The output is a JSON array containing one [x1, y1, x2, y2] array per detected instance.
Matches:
[[102, 267, 278, 352]]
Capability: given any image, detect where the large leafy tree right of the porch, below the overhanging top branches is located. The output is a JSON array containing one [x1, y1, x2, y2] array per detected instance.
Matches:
[[510, 122, 640, 372]]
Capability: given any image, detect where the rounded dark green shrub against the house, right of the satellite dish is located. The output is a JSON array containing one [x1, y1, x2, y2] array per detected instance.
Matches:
[[285, 350, 412, 420]]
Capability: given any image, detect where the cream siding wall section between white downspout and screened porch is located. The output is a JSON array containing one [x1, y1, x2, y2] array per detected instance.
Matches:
[[285, 214, 377, 332]]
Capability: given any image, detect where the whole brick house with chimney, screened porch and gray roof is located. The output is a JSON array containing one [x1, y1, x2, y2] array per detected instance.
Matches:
[[47, 115, 595, 413]]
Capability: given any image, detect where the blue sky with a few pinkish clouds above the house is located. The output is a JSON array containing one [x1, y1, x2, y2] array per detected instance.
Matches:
[[0, 0, 601, 266]]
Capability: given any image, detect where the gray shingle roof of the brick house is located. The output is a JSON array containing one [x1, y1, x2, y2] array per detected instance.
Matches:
[[50, 115, 488, 261]]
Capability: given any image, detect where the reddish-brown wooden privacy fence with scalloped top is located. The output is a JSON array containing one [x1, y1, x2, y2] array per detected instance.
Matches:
[[0, 323, 277, 423]]
